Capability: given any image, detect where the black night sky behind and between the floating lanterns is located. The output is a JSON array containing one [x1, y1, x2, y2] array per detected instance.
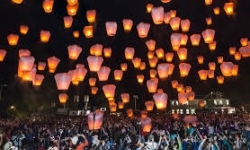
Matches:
[[0, 0, 250, 110]]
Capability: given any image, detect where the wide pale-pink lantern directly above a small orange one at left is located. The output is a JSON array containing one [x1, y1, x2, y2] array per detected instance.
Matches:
[[54, 73, 72, 90]]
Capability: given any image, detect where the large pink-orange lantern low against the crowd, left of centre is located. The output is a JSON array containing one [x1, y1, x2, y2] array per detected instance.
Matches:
[[88, 110, 103, 130]]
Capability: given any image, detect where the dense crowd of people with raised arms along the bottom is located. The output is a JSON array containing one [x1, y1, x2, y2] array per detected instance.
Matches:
[[0, 113, 250, 150]]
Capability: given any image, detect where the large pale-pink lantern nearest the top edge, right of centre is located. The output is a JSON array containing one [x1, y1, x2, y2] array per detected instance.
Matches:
[[151, 6, 164, 25]]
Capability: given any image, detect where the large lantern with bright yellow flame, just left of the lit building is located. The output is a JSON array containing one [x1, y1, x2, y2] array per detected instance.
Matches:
[[153, 93, 168, 110]]
